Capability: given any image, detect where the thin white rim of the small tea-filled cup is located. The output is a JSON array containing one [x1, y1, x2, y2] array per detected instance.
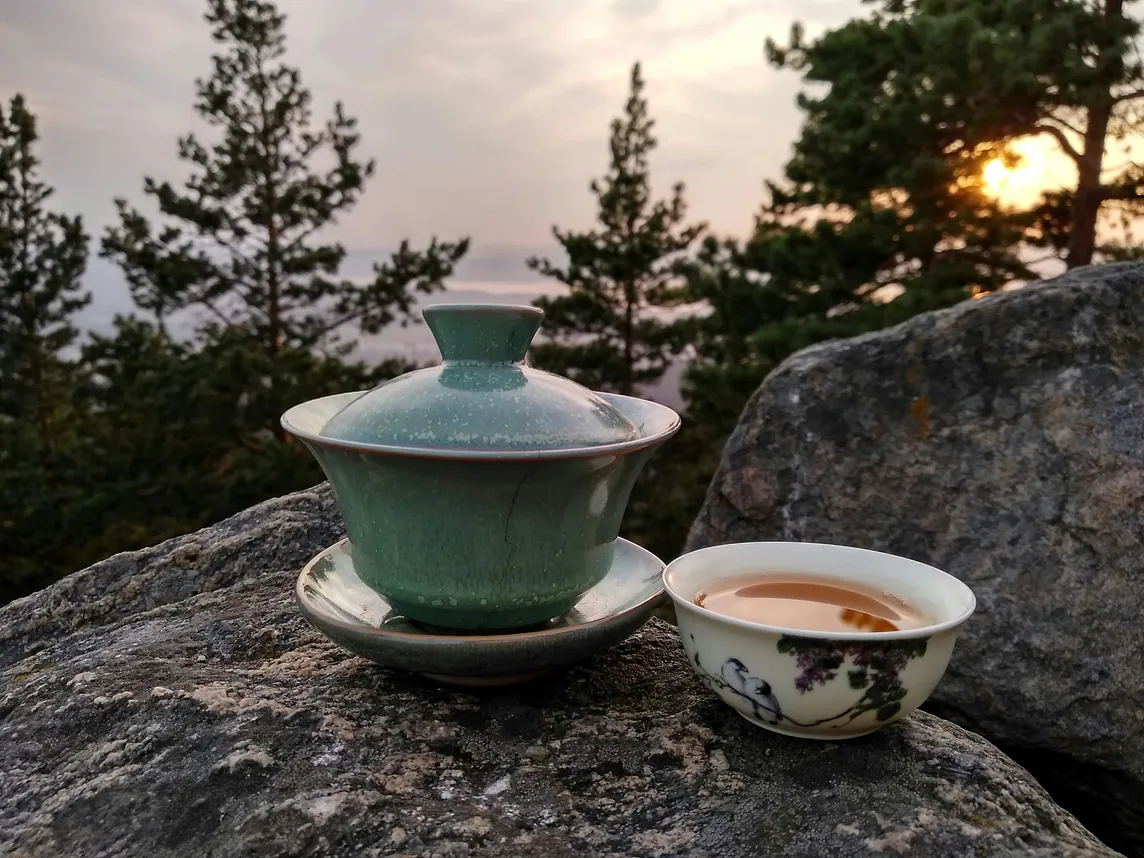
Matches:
[[662, 540, 977, 643]]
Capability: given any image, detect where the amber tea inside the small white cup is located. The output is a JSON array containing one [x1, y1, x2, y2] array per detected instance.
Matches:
[[693, 572, 931, 631]]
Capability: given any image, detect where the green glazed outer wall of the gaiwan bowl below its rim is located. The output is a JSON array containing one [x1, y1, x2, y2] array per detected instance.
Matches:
[[310, 437, 651, 628]]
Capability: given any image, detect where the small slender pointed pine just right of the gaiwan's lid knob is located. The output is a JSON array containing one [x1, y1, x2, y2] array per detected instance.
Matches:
[[527, 63, 705, 394]]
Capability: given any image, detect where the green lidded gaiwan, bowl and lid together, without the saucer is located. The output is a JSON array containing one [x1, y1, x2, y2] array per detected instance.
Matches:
[[281, 304, 680, 631]]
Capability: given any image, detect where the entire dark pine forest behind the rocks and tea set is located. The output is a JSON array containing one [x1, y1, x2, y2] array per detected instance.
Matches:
[[0, 0, 1144, 603]]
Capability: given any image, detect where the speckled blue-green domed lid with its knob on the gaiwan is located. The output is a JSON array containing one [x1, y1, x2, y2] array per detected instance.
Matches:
[[321, 304, 639, 452]]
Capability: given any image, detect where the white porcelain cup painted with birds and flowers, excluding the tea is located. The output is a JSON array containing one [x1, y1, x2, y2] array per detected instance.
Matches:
[[664, 542, 976, 739]]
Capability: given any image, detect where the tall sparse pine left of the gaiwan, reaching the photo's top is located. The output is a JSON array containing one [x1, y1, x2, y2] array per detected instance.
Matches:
[[103, 0, 468, 355]]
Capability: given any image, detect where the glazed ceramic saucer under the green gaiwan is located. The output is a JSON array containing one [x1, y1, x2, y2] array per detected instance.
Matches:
[[294, 539, 666, 685]]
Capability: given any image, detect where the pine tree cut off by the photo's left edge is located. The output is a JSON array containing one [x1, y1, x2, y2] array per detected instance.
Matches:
[[0, 95, 90, 603]]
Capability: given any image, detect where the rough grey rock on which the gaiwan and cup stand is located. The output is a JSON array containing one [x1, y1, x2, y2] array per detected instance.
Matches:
[[0, 488, 1117, 858]]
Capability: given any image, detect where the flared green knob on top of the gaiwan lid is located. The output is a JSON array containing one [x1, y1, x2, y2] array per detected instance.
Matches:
[[421, 304, 545, 364]]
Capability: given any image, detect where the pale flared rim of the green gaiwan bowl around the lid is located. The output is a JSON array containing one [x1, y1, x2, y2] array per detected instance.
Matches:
[[280, 390, 681, 461]]
